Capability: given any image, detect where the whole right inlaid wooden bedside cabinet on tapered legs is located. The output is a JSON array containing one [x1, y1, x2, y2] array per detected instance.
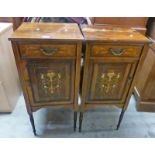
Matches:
[[79, 26, 149, 131]]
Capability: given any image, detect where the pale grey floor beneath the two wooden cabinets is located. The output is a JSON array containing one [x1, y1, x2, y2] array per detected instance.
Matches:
[[0, 96, 155, 138]]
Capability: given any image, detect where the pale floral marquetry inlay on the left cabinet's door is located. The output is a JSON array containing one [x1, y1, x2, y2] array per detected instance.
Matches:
[[40, 72, 62, 96]]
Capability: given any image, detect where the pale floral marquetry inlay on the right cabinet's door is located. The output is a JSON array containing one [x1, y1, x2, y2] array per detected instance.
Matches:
[[97, 70, 121, 94]]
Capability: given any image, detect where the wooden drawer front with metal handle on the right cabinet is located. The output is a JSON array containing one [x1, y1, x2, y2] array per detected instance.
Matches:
[[90, 44, 142, 57]]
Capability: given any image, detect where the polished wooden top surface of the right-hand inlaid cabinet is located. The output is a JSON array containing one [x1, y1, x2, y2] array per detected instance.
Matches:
[[81, 25, 150, 43]]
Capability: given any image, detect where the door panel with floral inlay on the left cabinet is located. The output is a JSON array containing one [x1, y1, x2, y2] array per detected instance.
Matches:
[[28, 60, 74, 105]]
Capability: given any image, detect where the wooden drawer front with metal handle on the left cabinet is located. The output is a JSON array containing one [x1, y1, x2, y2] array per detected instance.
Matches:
[[19, 43, 76, 58]]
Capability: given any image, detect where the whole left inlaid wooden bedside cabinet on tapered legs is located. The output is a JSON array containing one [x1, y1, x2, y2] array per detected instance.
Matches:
[[10, 23, 83, 135]]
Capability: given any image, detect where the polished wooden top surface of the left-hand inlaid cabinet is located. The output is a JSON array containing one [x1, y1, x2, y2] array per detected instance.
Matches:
[[10, 23, 83, 40]]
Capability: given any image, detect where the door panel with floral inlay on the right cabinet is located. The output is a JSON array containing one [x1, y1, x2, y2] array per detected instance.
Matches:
[[87, 60, 133, 103]]
